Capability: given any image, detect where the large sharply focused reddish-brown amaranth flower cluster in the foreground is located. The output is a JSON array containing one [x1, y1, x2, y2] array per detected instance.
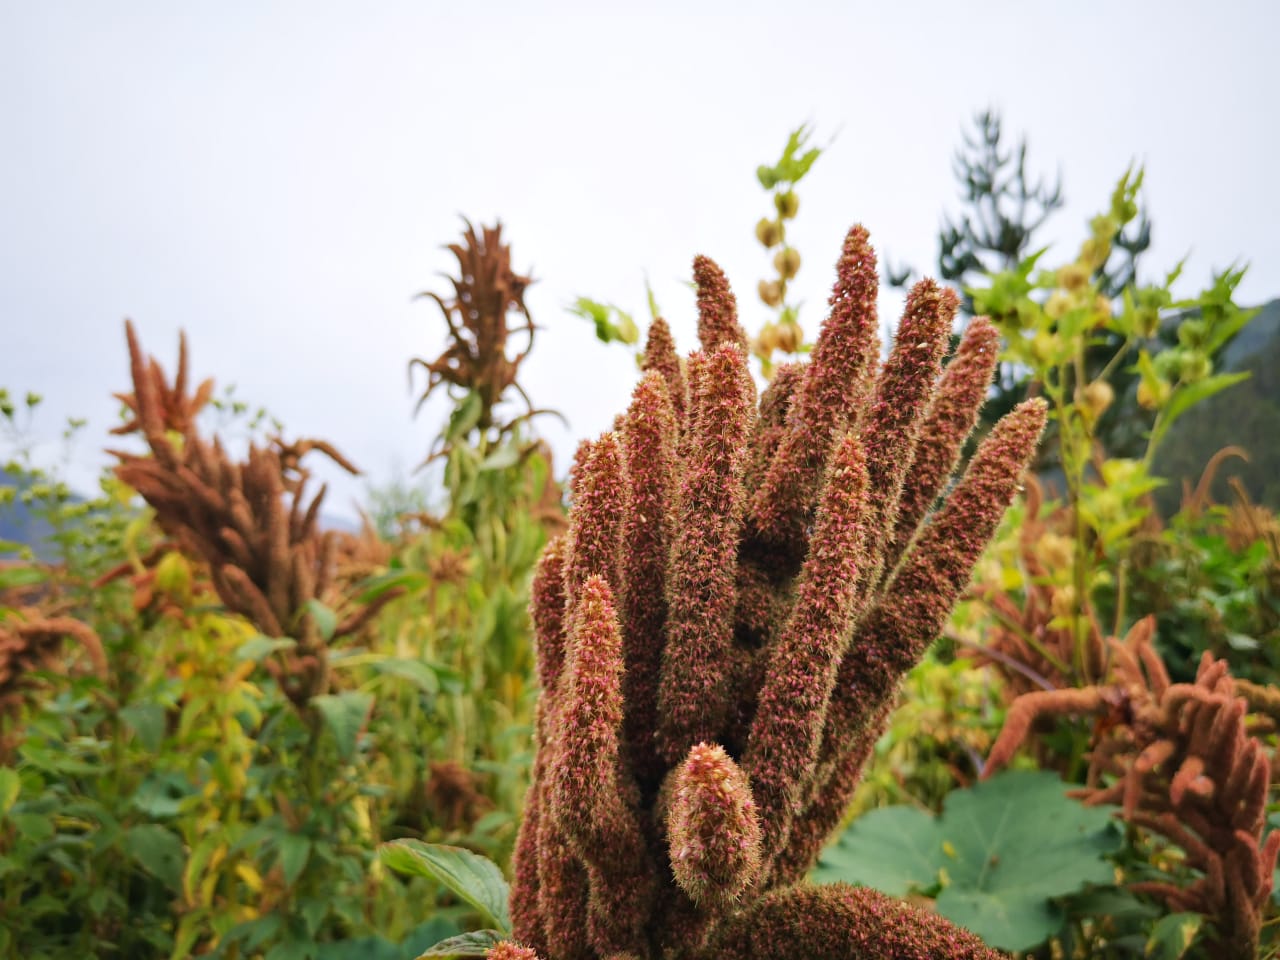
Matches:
[[493, 227, 1044, 960]]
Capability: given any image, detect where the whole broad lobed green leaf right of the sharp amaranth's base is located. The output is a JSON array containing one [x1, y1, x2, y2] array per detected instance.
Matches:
[[815, 771, 1120, 951]]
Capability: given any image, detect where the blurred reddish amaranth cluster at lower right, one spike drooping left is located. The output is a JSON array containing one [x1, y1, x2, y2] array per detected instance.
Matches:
[[987, 617, 1280, 960]]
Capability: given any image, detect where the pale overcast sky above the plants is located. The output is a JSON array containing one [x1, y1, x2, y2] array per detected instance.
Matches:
[[0, 0, 1280, 522]]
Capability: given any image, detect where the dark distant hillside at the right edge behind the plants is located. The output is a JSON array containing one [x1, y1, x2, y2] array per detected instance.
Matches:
[[1155, 300, 1280, 513]]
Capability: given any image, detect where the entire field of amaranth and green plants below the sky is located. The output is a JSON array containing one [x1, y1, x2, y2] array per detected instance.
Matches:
[[0, 128, 1280, 960]]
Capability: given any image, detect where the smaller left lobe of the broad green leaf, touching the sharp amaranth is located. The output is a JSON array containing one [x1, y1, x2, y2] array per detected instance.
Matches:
[[812, 806, 942, 897]]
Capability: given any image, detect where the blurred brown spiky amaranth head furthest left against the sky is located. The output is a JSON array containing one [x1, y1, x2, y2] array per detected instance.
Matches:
[[110, 321, 394, 709]]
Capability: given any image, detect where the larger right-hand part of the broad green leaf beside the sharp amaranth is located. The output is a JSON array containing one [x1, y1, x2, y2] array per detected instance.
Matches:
[[937, 771, 1120, 951]]
